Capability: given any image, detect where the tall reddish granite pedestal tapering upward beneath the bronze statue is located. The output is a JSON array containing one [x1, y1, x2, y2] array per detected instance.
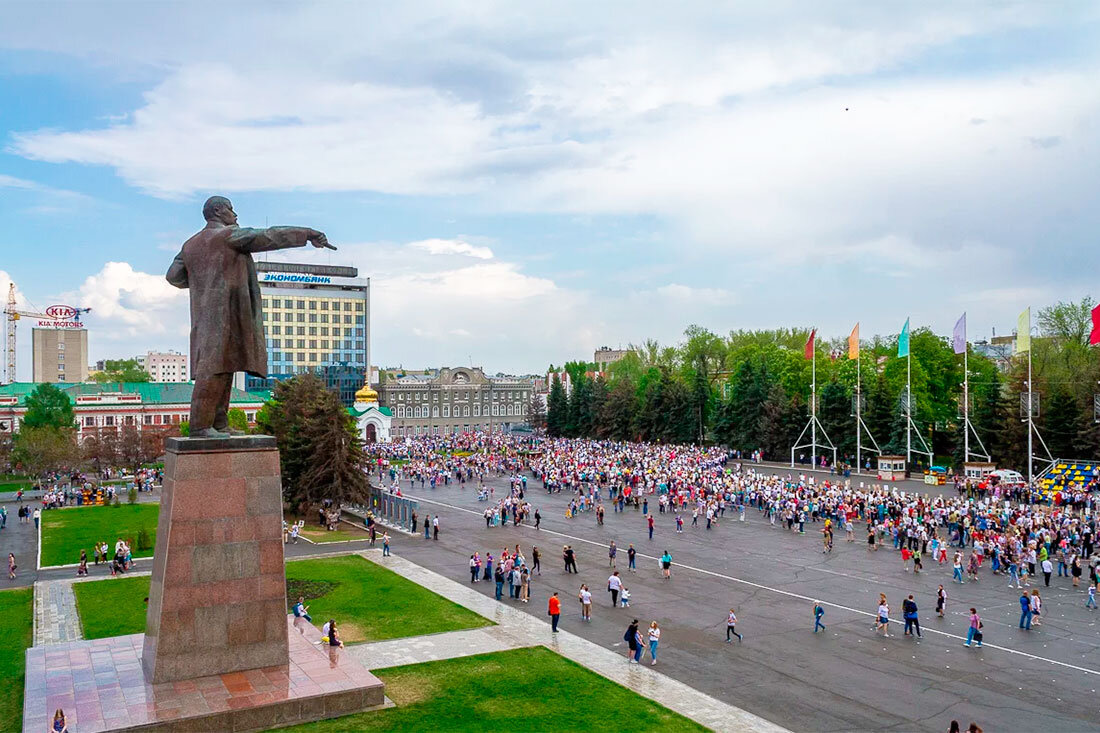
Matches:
[[142, 436, 288, 683]]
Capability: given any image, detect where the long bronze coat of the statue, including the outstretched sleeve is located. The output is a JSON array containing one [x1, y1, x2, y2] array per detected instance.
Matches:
[[166, 221, 312, 379]]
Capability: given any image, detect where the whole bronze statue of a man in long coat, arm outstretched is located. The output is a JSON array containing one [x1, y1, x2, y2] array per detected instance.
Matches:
[[166, 196, 337, 438]]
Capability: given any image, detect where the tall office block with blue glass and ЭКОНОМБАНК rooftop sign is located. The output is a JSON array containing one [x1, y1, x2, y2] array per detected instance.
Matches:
[[245, 262, 371, 406]]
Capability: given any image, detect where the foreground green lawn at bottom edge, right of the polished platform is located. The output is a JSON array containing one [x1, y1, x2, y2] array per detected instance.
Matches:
[[279, 646, 706, 733]]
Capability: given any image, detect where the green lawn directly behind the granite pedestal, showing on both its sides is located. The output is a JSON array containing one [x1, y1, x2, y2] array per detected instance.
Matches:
[[65, 555, 492, 643]]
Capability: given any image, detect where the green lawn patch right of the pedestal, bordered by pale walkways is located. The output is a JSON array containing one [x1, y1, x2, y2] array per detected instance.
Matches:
[[286, 555, 492, 643]]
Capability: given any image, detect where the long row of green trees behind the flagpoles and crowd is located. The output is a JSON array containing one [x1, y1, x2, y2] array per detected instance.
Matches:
[[546, 298, 1100, 470]]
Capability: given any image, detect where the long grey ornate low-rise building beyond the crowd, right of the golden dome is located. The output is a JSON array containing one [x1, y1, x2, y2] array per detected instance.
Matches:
[[380, 367, 535, 439]]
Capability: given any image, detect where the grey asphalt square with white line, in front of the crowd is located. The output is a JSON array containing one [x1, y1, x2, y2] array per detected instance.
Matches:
[[360, 469, 1100, 731]]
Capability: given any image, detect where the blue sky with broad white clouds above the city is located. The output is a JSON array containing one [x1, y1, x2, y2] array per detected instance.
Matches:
[[0, 2, 1100, 375]]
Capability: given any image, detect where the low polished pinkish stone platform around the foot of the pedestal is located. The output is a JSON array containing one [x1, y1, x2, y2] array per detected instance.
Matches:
[[23, 615, 387, 733]]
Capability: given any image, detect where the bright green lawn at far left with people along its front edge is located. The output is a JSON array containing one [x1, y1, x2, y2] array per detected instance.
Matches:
[[39, 504, 161, 567]]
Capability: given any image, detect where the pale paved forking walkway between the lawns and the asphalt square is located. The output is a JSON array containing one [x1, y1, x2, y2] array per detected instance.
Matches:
[[356, 549, 787, 733]]
